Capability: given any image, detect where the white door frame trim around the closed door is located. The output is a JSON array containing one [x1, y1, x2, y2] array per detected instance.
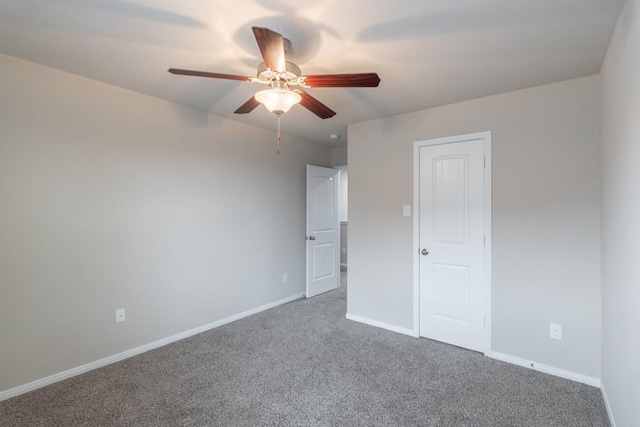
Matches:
[[413, 131, 491, 356]]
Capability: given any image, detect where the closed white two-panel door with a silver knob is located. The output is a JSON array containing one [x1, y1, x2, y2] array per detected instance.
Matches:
[[418, 139, 485, 351]]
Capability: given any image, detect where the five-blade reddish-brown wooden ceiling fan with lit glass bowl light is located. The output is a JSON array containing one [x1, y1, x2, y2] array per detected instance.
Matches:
[[169, 27, 380, 119]]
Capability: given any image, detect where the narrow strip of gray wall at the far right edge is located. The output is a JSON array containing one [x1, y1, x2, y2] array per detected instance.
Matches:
[[601, 0, 640, 427]]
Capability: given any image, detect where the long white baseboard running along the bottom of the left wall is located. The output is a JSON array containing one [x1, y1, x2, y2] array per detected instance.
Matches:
[[0, 293, 304, 402]]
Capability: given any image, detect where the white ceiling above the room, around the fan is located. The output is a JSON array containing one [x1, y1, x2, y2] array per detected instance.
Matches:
[[0, 0, 624, 146]]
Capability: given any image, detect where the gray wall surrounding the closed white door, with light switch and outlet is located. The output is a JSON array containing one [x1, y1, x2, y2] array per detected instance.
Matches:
[[348, 76, 601, 378]]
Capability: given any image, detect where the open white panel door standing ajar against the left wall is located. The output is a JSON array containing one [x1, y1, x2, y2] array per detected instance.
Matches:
[[306, 165, 340, 298]]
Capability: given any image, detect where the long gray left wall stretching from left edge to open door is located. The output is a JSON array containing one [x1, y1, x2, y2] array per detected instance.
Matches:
[[0, 55, 330, 391]]
